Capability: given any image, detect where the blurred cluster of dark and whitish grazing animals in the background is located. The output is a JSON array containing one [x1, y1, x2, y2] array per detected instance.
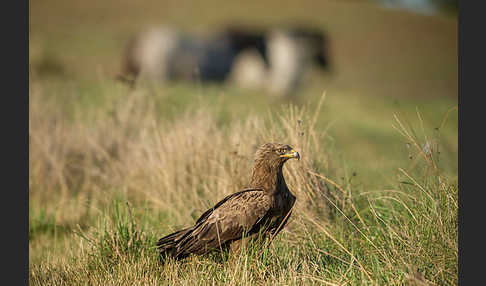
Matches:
[[119, 24, 329, 95]]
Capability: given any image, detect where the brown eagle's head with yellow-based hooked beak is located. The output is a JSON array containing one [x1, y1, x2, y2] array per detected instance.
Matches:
[[256, 143, 300, 166]]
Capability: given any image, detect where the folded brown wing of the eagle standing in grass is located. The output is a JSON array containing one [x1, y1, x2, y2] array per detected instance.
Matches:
[[169, 189, 271, 257]]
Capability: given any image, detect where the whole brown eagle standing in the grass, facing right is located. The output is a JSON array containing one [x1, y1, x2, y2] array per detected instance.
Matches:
[[157, 143, 300, 259]]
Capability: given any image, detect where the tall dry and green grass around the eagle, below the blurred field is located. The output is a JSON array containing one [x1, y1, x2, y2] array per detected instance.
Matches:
[[29, 90, 458, 285]]
